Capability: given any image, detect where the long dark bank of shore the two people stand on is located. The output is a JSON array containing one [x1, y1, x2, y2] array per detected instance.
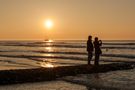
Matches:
[[0, 63, 135, 85]]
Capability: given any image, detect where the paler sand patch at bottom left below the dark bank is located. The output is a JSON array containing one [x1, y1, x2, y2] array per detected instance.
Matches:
[[0, 81, 87, 90]]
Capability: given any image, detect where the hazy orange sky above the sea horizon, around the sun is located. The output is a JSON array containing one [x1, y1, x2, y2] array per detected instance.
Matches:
[[0, 0, 135, 40]]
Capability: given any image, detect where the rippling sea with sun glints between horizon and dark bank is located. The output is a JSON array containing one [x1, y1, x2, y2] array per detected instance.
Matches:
[[0, 40, 135, 70]]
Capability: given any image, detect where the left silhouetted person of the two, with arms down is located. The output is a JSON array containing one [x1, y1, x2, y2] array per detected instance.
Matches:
[[87, 36, 93, 65]]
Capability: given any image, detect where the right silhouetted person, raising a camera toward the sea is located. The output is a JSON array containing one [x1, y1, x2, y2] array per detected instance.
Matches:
[[94, 37, 102, 66]]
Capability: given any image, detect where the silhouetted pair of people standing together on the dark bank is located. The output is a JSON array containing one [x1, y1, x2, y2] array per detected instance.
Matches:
[[87, 36, 102, 66]]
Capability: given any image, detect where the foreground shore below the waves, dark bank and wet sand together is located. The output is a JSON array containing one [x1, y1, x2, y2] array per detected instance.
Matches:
[[0, 63, 135, 90]]
